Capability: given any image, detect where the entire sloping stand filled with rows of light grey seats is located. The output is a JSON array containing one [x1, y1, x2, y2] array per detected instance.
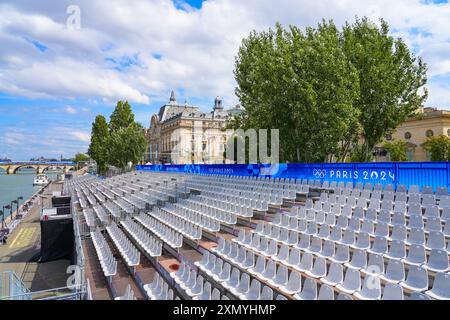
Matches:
[[64, 171, 450, 300]]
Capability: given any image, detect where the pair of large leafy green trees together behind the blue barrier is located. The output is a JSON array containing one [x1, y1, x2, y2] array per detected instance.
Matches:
[[234, 18, 428, 162]]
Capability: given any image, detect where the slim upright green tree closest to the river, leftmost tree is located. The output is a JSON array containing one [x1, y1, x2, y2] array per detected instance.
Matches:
[[88, 115, 109, 173]]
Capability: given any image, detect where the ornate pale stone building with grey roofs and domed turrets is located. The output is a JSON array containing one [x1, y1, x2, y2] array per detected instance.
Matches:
[[144, 91, 242, 164]]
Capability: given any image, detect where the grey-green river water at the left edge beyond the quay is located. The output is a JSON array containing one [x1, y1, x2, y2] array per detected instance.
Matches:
[[0, 170, 56, 218]]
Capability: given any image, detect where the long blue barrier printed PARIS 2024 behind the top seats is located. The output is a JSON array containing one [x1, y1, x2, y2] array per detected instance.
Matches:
[[136, 162, 450, 190]]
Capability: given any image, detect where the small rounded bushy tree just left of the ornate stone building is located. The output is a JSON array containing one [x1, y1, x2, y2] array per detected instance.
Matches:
[[108, 122, 147, 169]]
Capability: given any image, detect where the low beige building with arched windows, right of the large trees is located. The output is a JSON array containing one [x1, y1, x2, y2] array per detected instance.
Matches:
[[375, 107, 450, 162]]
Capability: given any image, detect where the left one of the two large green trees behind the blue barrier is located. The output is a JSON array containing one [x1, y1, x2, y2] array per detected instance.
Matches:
[[234, 21, 360, 162]]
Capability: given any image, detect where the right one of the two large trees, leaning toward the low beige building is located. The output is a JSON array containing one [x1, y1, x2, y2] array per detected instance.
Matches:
[[342, 18, 428, 161]]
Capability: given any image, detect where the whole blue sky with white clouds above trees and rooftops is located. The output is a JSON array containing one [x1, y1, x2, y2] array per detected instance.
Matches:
[[0, 0, 450, 160]]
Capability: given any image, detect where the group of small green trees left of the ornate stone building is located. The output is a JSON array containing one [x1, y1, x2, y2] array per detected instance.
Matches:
[[88, 101, 147, 173]]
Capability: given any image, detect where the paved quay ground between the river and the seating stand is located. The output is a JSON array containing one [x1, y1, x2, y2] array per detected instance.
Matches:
[[0, 183, 70, 291]]
